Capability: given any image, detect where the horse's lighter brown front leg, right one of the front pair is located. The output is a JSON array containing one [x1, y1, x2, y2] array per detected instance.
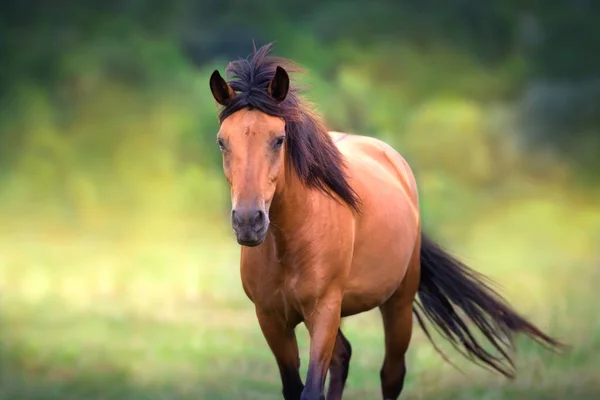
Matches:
[[301, 293, 342, 400]]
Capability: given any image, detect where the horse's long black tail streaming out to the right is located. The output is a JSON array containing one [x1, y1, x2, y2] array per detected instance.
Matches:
[[414, 234, 563, 378]]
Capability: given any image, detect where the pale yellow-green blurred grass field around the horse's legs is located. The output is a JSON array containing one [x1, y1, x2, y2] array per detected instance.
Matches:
[[0, 206, 600, 400]]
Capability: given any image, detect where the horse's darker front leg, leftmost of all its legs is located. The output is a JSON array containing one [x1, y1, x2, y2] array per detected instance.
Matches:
[[256, 309, 304, 400]]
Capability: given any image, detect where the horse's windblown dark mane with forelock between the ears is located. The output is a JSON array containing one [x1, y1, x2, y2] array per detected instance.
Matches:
[[219, 44, 360, 211]]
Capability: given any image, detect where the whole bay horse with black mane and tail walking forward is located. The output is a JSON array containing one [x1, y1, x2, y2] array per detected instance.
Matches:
[[209, 44, 561, 400]]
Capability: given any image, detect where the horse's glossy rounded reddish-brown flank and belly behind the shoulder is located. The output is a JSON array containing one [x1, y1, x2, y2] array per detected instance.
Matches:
[[330, 132, 420, 314]]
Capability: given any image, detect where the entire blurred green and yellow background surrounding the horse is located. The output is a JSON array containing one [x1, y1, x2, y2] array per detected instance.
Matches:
[[0, 0, 600, 400]]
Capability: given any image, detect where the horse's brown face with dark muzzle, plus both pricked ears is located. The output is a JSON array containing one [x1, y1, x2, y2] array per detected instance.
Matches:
[[211, 66, 288, 247]]
